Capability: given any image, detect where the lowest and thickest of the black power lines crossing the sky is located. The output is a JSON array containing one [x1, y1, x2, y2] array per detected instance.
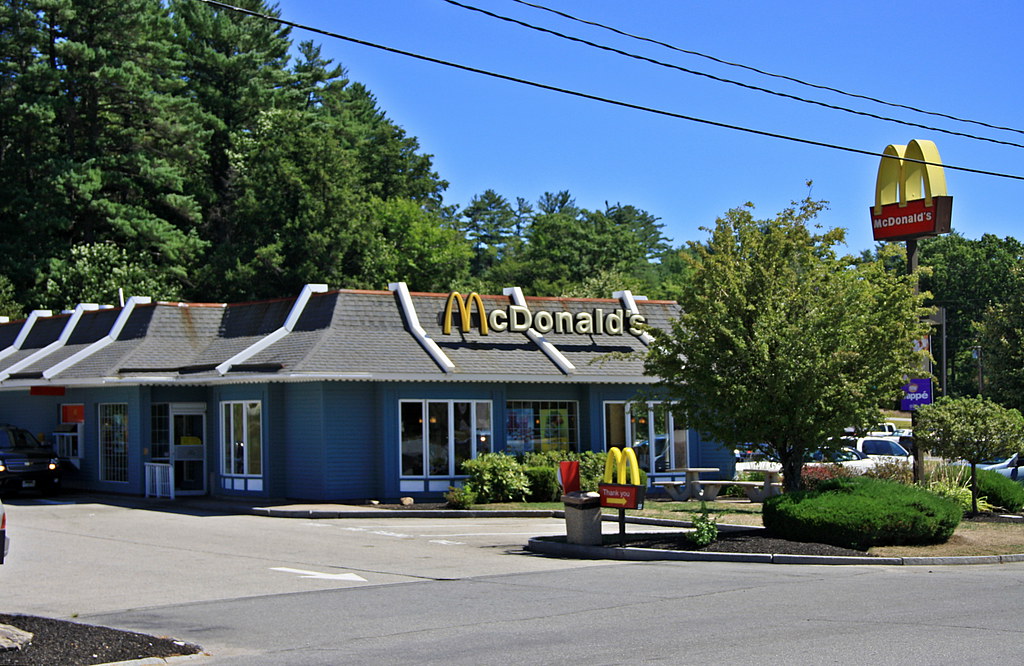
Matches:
[[192, 0, 1024, 180]]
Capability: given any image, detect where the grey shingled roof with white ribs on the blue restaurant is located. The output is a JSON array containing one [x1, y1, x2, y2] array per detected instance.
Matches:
[[0, 283, 679, 389]]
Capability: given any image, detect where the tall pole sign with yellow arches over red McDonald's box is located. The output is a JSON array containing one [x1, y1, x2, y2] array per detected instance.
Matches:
[[871, 139, 953, 241]]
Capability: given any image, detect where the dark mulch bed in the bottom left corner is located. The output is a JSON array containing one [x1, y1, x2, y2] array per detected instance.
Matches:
[[0, 615, 202, 666]]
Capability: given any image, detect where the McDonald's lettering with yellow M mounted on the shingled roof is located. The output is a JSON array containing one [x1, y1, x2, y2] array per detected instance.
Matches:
[[441, 291, 646, 336]]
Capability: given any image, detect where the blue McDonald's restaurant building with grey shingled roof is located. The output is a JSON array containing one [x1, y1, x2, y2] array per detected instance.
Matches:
[[0, 283, 733, 501]]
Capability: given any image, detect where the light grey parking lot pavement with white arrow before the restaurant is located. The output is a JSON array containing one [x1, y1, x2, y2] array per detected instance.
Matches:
[[0, 496, 688, 617]]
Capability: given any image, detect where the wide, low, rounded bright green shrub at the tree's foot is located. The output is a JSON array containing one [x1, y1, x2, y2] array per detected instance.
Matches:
[[762, 477, 963, 550]]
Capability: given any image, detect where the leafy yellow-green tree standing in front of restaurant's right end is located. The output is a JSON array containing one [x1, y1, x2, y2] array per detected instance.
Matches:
[[645, 194, 925, 491]]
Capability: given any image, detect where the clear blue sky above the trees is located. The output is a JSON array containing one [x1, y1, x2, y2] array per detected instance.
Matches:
[[268, 0, 1024, 252]]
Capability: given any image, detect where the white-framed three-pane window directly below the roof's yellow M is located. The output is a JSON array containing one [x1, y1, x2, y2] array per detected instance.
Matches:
[[398, 400, 492, 476]]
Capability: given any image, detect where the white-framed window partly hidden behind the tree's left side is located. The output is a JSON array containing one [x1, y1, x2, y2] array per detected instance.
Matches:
[[604, 403, 687, 474]]
